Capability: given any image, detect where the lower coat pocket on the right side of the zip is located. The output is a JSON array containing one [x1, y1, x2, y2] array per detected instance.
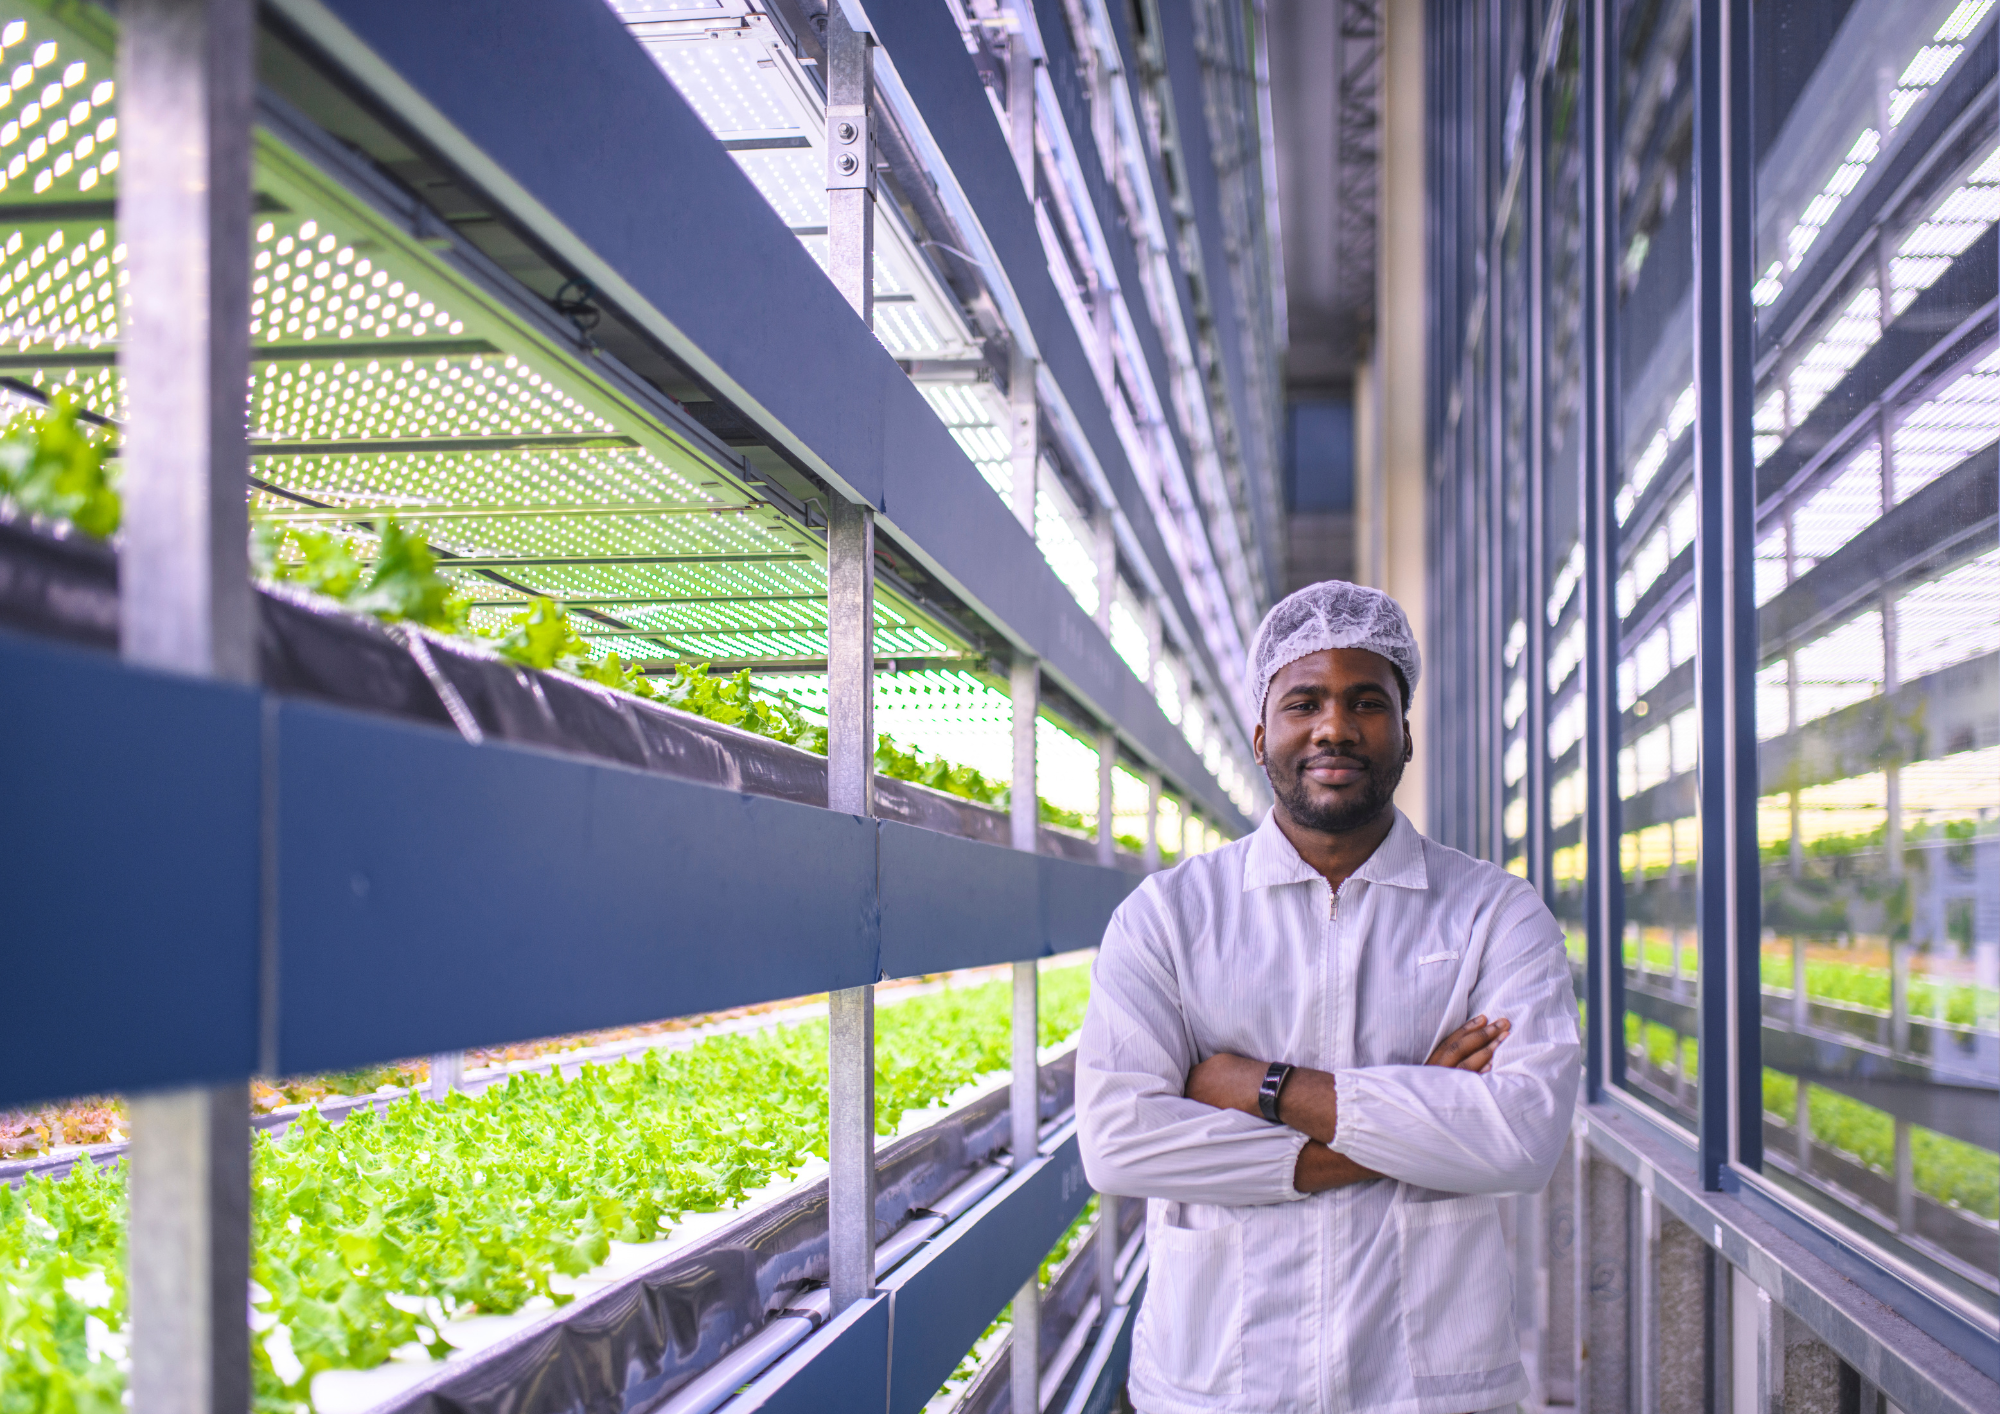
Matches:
[[1396, 1194, 1520, 1378]]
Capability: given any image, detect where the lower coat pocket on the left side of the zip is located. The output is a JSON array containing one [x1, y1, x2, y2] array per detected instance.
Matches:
[[1140, 1222, 1244, 1394]]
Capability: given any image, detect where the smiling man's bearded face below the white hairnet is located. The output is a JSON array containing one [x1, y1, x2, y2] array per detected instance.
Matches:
[[1254, 648, 1410, 834]]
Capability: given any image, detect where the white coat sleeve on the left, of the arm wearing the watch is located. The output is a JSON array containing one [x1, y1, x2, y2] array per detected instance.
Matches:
[[1076, 882, 1306, 1206]]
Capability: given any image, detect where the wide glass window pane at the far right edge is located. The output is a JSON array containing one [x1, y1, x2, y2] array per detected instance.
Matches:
[[1744, 0, 2000, 1310]]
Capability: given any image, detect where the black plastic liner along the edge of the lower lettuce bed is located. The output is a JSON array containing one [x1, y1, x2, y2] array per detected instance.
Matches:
[[386, 1052, 1076, 1414]]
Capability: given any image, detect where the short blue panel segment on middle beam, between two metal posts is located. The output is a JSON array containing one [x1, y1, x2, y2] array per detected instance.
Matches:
[[880, 820, 1048, 978]]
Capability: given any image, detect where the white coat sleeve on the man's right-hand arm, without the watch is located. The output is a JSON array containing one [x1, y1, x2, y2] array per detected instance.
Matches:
[[1332, 886, 1582, 1194]]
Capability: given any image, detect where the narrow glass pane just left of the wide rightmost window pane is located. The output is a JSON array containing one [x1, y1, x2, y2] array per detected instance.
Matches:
[[1608, 6, 1700, 1128]]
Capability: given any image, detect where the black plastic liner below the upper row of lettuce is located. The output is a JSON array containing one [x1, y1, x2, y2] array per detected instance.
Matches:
[[0, 514, 1144, 874]]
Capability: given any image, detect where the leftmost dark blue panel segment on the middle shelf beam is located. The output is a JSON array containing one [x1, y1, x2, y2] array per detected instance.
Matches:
[[0, 634, 260, 1106]]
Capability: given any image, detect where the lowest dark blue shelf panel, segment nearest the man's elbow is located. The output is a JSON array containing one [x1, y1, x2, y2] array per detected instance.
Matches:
[[886, 1136, 1090, 1414]]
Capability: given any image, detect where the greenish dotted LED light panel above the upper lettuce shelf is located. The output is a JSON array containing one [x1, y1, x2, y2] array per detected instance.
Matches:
[[0, 4, 964, 680]]
